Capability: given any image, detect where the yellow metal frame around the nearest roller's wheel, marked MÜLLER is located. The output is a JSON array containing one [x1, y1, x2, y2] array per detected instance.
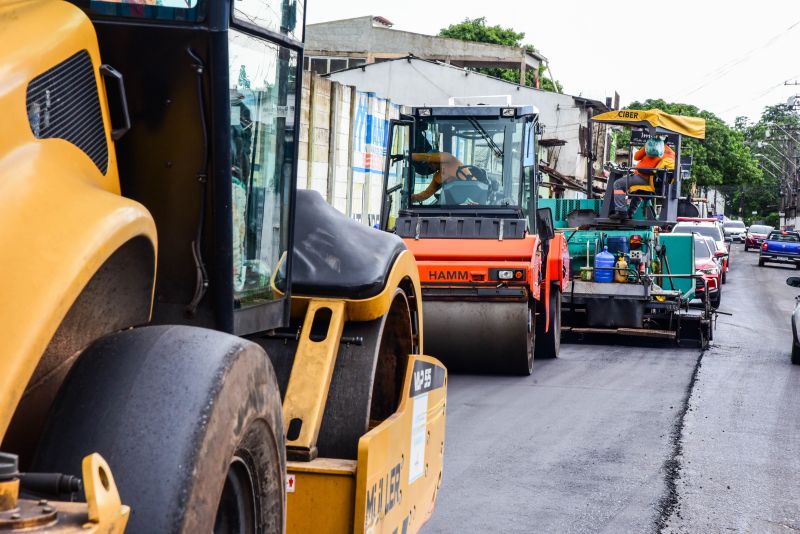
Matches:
[[283, 251, 447, 533]]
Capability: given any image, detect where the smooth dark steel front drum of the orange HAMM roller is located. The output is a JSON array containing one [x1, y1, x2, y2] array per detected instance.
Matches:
[[423, 300, 534, 375]]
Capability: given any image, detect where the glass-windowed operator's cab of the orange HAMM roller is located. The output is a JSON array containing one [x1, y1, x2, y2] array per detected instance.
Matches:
[[382, 106, 536, 234]]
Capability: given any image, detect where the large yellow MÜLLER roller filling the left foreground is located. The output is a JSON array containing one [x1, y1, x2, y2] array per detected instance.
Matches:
[[0, 0, 447, 533]]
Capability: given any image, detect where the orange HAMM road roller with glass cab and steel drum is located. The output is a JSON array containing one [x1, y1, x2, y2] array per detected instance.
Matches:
[[381, 105, 569, 375]]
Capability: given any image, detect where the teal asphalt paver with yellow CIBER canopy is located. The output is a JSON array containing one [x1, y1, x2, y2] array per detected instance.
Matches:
[[541, 110, 714, 347]]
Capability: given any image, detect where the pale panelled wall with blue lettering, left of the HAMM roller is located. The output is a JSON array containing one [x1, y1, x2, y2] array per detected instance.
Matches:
[[297, 76, 400, 225]]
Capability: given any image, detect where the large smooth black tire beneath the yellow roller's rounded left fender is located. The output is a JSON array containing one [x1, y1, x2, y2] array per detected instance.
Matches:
[[33, 326, 286, 534]]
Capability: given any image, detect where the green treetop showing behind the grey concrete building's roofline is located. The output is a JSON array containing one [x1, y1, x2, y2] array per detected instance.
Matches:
[[439, 17, 563, 93]]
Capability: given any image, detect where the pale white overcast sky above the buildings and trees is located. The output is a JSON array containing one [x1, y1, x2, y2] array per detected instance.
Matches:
[[307, 0, 800, 123]]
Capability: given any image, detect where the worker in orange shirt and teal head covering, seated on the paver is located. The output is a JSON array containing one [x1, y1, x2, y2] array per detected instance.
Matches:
[[610, 137, 675, 219]]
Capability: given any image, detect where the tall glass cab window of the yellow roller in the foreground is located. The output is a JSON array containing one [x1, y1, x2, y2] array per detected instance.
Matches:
[[228, 29, 297, 307]]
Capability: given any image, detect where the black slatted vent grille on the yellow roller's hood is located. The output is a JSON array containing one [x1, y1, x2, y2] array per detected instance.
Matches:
[[26, 50, 108, 174]]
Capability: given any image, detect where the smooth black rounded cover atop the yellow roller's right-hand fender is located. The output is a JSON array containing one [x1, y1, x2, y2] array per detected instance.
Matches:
[[279, 190, 406, 299]]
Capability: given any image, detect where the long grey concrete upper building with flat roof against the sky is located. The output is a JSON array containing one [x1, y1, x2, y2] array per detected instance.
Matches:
[[305, 15, 547, 85]]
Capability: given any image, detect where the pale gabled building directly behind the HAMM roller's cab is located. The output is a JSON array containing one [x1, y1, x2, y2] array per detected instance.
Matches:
[[328, 57, 611, 198]]
